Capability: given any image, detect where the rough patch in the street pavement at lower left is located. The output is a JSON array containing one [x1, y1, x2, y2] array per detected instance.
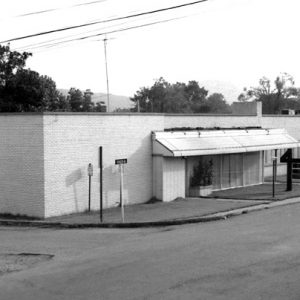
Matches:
[[0, 253, 54, 276]]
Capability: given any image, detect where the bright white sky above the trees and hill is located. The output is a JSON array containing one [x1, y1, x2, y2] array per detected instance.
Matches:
[[0, 0, 300, 102]]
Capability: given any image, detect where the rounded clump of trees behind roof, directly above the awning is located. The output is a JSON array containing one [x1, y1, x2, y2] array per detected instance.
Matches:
[[130, 77, 230, 113]]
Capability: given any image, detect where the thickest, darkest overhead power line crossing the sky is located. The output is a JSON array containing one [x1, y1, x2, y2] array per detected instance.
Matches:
[[0, 0, 208, 43]]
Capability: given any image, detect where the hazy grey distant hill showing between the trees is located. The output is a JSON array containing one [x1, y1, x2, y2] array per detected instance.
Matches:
[[59, 89, 133, 112]]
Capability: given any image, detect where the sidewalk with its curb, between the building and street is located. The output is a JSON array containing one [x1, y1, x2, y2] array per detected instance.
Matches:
[[0, 197, 300, 228]]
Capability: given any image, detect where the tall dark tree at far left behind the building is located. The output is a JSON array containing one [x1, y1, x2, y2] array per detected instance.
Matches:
[[0, 45, 65, 112]]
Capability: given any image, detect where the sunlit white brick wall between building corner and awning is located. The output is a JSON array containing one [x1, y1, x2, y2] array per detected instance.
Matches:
[[44, 114, 164, 217]]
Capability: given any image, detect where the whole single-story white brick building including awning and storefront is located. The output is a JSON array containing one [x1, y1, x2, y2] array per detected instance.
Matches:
[[0, 105, 300, 218]]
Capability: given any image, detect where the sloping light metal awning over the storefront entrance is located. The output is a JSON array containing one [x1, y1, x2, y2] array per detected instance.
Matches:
[[153, 129, 300, 157]]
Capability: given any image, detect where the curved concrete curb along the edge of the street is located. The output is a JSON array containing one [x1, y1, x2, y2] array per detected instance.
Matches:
[[0, 198, 300, 229]]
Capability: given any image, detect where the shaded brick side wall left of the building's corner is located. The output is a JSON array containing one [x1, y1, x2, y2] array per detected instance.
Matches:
[[0, 114, 44, 217]]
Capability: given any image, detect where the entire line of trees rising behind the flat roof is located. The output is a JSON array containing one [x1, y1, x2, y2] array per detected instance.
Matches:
[[0, 41, 300, 114]]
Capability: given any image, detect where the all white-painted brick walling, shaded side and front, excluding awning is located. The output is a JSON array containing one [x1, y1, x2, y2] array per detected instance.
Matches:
[[0, 114, 300, 217]]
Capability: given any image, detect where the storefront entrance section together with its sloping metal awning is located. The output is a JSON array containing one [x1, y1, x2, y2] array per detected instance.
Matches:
[[153, 129, 300, 201]]
